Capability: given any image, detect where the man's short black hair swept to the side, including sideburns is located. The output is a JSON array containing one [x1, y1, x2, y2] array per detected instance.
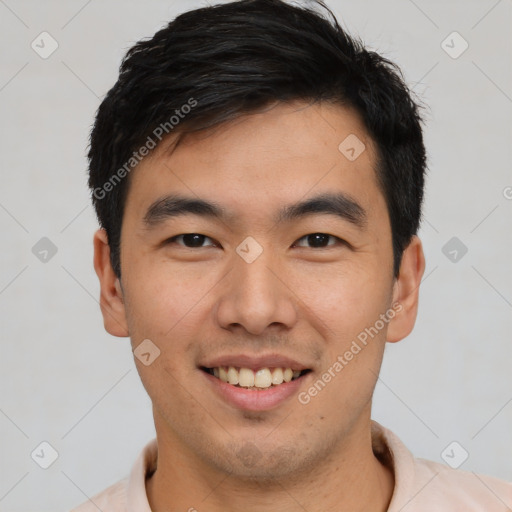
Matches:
[[88, 0, 426, 277]]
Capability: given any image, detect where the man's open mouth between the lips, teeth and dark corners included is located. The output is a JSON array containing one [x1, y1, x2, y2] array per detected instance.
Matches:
[[200, 366, 311, 391]]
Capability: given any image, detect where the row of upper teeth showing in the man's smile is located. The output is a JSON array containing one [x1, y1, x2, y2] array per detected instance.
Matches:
[[213, 366, 300, 388]]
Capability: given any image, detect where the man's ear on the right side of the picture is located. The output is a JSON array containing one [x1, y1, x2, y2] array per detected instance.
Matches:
[[387, 236, 425, 343]]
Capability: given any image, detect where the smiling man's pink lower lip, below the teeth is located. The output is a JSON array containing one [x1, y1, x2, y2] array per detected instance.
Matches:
[[200, 370, 309, 411]]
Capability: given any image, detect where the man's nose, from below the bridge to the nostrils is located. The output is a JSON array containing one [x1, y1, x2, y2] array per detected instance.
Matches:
[[216, 247, 297, 335]]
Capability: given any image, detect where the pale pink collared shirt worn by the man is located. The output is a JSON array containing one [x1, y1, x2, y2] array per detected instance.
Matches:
[[71, 421, 512, 512]]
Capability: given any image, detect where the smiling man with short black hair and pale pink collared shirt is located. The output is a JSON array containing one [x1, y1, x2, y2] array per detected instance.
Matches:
[[76, 0, 512, 512]]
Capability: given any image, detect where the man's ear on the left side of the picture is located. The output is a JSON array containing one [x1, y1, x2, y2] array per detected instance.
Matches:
[[94, 229, 129, 337]]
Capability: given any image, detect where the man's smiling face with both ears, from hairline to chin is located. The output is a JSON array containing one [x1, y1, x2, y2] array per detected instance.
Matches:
[[95, 99, 423, 478]]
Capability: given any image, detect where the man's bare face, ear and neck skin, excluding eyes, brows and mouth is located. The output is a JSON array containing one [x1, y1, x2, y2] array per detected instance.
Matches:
[[94, 102, 425, 512]]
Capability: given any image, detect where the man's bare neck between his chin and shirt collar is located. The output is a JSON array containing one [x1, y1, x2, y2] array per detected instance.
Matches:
[[146, 417, 394, 512]]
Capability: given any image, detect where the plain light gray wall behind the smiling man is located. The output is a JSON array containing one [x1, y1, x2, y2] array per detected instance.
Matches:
[[0, 0, 512, 511]]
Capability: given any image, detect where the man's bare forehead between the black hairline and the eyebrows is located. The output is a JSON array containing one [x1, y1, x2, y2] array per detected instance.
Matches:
[[127, 103, 384, 228]]
